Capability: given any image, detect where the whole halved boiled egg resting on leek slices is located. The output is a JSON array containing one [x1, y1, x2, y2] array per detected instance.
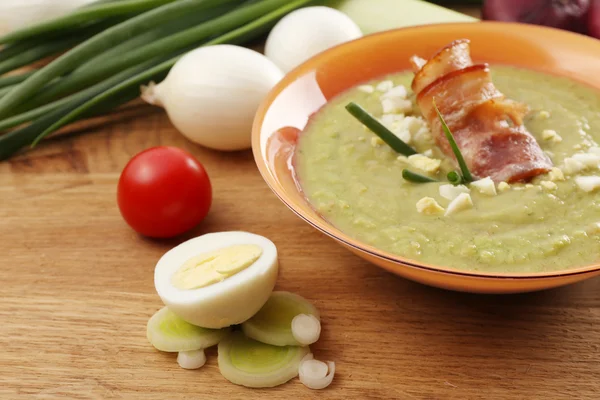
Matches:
[[154, 232, 279, 329]]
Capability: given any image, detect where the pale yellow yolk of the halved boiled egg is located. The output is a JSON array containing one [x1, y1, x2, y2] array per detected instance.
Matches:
[[171, 244, 262, 290]]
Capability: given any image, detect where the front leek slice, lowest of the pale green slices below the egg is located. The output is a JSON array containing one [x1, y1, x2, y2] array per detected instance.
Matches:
[[219, 331, 310, 388]]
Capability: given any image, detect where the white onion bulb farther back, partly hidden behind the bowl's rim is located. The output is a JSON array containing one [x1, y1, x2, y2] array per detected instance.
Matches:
[[265, 6, 362, 73]]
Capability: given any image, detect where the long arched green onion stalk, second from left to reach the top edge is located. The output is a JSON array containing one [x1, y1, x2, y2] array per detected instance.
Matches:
[[0, 0, 237, 118]]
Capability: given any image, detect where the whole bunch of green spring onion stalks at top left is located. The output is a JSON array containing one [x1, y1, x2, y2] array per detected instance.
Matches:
[[0, 0, 315, 160]]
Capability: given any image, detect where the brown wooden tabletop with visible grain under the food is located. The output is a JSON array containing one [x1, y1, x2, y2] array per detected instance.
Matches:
[[0, 5, 600, 400]]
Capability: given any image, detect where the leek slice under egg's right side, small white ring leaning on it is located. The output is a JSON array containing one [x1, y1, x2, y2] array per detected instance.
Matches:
[[242, 291, 321, 346]]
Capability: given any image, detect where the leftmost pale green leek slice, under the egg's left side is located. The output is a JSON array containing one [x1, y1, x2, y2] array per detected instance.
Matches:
[[146, 307, 229, 352]]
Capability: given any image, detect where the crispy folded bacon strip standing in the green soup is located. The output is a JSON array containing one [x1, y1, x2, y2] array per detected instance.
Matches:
[[411, 40, 552, 182]]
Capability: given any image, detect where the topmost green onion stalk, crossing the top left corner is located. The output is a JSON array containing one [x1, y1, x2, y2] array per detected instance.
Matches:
[[0, 0, 176, 44]]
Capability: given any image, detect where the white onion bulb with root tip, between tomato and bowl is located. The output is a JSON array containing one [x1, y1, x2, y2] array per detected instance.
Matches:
[[142, 45, 283, 151]]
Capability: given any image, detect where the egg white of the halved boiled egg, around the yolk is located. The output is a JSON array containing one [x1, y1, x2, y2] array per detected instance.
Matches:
[[154, 231, 279, 329]]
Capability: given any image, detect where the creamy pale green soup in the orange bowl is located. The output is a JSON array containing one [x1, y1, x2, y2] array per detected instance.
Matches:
[[294, 66, 600, 273]]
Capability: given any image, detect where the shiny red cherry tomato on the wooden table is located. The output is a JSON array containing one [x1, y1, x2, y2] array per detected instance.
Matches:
[[117, 146, 212, 238]]
